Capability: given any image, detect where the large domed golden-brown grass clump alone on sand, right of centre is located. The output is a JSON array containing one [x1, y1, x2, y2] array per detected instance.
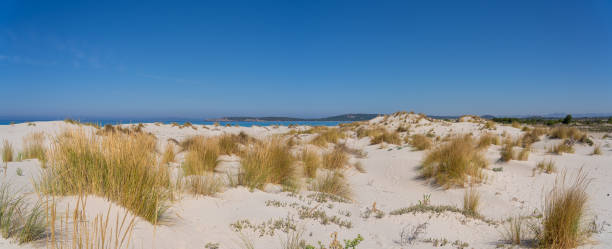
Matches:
[[421, 135, 488, 188]]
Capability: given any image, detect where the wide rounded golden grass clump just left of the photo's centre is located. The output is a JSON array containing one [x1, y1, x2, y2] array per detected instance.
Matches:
[[238, 138, 296, 189]]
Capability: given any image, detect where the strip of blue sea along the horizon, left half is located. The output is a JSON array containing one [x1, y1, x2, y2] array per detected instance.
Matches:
[[0, 119, 351, 127]]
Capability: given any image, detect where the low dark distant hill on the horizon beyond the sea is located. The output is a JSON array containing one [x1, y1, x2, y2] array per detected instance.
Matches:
[[206, 113, 381, 122]]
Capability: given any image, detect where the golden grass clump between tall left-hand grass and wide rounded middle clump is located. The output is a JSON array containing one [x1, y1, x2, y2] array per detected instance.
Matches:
[[183, 136, 220, 175]]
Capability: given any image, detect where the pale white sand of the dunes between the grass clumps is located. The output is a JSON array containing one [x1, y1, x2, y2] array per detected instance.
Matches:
[[0, 115, 612, 249]]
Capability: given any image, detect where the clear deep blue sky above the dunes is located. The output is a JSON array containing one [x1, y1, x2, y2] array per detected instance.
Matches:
[[0, 0, 612, 118]]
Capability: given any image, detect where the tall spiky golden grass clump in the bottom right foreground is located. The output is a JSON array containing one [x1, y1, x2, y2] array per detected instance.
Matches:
[[535, 170, 590, 249]]
